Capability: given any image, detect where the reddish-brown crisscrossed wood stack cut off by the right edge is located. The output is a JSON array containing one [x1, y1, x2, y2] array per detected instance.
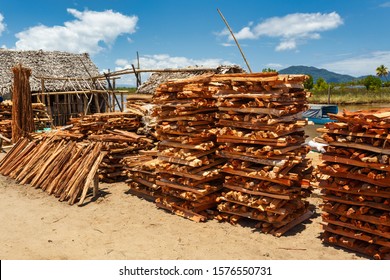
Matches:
[[318, 109, 390, 259]]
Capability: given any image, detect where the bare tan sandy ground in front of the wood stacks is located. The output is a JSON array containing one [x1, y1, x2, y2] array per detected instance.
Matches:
[[0, 151, 365, 260]]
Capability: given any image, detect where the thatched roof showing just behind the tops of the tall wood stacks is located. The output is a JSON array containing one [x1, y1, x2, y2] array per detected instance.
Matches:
[[137, 65, 245, 94]]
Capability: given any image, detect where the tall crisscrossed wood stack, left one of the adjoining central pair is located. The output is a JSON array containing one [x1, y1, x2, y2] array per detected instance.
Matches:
[[153, 75, 224, 222]]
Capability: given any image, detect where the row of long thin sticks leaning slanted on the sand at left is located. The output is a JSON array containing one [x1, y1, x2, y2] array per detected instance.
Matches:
[[0, 134, 105, 205]]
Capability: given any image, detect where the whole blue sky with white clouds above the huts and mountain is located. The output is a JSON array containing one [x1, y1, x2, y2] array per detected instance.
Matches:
[[0, 0, 390, 84]]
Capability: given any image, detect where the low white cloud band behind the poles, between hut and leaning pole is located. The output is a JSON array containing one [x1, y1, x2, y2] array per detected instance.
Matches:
[[115, 54, 233, 85]]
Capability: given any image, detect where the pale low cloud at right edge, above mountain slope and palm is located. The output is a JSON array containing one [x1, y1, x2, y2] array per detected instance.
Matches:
[[321, 51, 390, 77]]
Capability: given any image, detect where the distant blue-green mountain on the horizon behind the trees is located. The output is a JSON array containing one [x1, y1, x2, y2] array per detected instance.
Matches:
[[278, 66, 358, 83]]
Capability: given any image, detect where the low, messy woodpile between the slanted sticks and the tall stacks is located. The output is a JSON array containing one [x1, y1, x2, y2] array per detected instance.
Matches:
[[69, 113, 155, 182]]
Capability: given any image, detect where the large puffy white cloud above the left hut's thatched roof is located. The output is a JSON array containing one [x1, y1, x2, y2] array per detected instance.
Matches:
[[15, 9, 138, 54]]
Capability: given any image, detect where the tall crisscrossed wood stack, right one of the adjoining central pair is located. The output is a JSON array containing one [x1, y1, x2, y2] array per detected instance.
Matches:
[[211, 73, 312, 236]]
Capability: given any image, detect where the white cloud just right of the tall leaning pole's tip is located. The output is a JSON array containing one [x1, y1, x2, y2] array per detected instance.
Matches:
[[218, 12, 343, 51]]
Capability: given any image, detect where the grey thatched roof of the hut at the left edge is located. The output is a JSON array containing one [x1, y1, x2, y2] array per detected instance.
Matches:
[[0, 49, 99, 94]]
